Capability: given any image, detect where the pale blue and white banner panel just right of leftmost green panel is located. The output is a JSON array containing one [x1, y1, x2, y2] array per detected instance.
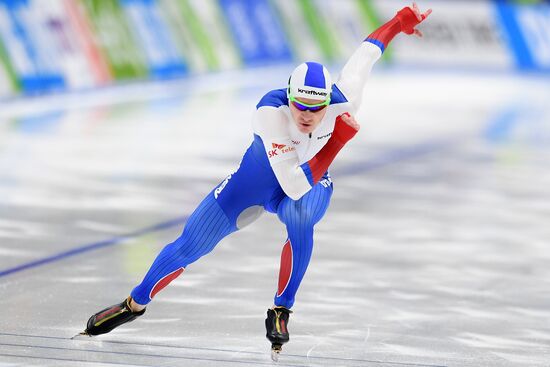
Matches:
[[120, 0, 187, 78]]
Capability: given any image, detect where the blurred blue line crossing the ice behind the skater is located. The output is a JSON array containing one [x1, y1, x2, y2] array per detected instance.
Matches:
[[0, 136, 460, 278]]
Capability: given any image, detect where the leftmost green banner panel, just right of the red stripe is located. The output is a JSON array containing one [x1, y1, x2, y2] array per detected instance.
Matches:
[[80, 0, 148, 80]]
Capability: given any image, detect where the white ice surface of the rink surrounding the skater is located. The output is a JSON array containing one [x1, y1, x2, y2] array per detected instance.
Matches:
[[0, 66, 550, 367]]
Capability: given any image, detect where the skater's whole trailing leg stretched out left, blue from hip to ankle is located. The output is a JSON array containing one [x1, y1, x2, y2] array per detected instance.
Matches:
[[131, 145, 277, 305]]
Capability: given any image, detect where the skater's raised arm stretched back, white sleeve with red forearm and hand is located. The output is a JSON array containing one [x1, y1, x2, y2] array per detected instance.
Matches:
[[336, 3, 432, 109]]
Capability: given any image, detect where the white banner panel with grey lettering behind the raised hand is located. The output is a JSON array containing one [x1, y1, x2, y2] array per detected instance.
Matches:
[[374, 0, 514, 70]]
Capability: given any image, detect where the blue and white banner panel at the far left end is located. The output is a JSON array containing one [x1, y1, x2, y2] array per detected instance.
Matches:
[[0, 0, 65, 94]]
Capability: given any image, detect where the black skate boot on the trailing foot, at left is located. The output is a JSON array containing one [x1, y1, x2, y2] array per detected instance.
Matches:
[[79, 297, 145, 336]]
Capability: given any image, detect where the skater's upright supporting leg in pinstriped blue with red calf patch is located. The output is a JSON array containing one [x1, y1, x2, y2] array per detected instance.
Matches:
[[274, 178, 332, 308]]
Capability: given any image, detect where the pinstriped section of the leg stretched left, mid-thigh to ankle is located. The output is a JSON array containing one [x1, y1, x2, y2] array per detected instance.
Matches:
[[131, 193, 237, 305]]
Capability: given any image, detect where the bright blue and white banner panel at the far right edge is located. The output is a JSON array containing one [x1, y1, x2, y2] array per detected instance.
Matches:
[[496, 2, 550, 71]]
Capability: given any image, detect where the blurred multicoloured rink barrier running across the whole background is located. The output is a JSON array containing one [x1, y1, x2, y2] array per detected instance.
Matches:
[[0, 0, 550, 97]]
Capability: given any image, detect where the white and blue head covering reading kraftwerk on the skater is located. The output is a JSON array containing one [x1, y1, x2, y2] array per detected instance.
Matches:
[[288, 61, 332, 101]]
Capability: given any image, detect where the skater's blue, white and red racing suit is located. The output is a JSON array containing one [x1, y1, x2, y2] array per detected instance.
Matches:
[[131, 8, 424, 308]]
